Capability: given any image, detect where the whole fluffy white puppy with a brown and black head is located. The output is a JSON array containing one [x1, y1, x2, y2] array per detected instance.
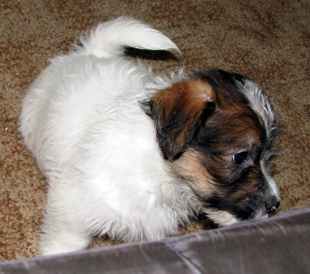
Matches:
[[20, 17, 280, 254]]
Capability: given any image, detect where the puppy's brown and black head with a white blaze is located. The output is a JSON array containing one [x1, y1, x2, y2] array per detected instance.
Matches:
[[150, 70, 280, 225]]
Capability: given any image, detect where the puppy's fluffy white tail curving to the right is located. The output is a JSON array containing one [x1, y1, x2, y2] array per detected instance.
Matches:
[[79, 17, 180, 58]]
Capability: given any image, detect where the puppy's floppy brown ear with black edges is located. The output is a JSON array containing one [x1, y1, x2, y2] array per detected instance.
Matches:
[[150, 79, 216, 160]]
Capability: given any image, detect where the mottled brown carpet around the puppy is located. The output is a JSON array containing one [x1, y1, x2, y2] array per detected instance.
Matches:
[[0, 0, 310, 260]]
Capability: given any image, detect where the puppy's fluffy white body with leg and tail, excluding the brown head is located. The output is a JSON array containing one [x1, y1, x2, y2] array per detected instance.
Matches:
[[20, 18, 200, 254]]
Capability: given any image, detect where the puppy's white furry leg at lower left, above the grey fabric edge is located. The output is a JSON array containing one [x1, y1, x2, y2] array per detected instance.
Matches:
[[38, 180, 92, 255]]
